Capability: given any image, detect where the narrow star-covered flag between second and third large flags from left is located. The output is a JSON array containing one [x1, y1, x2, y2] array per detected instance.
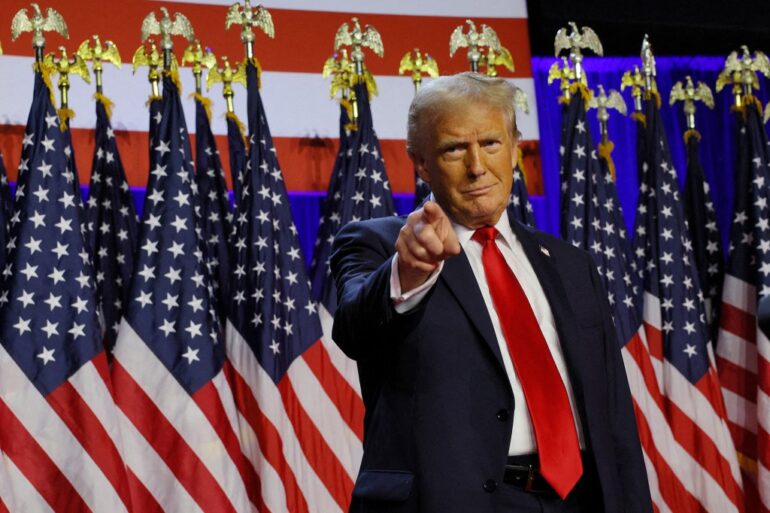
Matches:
[[195, 95, 233, 320]]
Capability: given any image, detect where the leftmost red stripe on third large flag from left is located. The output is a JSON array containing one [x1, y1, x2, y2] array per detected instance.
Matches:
[[226, 367, 309, 513]]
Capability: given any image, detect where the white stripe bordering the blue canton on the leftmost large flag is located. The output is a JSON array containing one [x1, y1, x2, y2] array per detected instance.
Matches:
[[0, 345, 126, 512]]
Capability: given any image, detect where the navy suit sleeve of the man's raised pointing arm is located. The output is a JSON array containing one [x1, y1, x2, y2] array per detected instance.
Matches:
[[331, 219, 422, 361]]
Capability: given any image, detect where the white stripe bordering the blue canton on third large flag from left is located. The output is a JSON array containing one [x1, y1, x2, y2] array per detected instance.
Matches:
[[226, 320, 341, 513]]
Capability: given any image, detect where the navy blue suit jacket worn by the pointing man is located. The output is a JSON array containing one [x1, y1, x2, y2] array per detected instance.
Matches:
[[331, 217, 652, 513]]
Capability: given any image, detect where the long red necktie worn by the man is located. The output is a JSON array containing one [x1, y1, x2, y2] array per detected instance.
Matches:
[[473, 226, 583, 498]]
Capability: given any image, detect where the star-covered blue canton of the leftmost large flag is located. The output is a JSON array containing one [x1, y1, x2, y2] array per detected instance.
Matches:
[[0, 73, 103, 395]]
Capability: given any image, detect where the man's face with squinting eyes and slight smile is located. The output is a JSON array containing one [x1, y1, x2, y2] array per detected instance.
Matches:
[[412, 103, 516, 228]]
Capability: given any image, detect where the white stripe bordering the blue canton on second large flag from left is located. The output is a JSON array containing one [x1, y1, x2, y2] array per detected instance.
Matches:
[[115, 319, 250, 511]]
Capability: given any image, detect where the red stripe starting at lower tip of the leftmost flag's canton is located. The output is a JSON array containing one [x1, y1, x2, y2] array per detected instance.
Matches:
[[46, 376, 131, 511]]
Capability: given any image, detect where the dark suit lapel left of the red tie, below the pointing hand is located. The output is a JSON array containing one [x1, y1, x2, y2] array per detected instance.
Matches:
[[440, 251, 505, 371]]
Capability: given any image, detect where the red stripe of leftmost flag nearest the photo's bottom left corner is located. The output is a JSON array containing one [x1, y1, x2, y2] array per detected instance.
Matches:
[[0, 400, 91, 513]]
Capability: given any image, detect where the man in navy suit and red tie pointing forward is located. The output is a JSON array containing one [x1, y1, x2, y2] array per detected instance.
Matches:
[[331, 73, 652, 513]]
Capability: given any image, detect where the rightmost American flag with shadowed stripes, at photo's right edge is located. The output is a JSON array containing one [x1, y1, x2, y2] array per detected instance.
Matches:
[[716, 96, 770, 512]]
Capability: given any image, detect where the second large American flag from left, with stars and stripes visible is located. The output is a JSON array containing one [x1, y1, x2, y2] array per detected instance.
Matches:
[[112, 77, 255, 513]]
